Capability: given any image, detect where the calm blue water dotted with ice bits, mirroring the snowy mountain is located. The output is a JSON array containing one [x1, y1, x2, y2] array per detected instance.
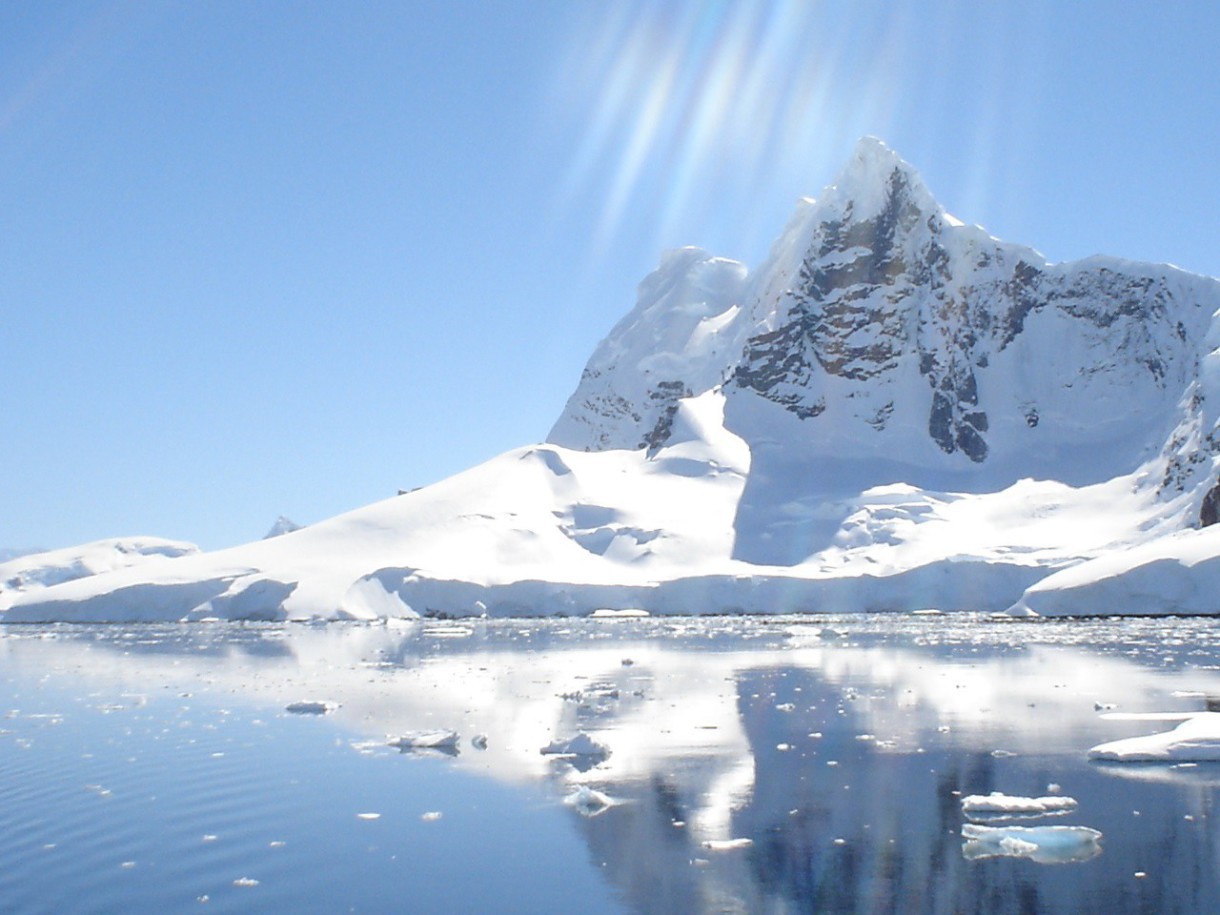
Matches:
[[0, 616, 1220, 915]]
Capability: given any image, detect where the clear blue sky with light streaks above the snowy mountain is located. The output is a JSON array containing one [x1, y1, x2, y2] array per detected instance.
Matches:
[[0, 0, 1220, 548]]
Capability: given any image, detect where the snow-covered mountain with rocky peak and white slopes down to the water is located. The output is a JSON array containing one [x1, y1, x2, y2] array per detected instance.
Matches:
[[7, 139, 1220, 620]]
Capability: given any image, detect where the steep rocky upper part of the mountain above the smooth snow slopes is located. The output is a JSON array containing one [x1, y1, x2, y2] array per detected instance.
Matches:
[[550, 139, 1220, 490]]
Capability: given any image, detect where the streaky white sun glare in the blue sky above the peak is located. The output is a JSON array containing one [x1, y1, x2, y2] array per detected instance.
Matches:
[[549, 0, 904, 264]]
